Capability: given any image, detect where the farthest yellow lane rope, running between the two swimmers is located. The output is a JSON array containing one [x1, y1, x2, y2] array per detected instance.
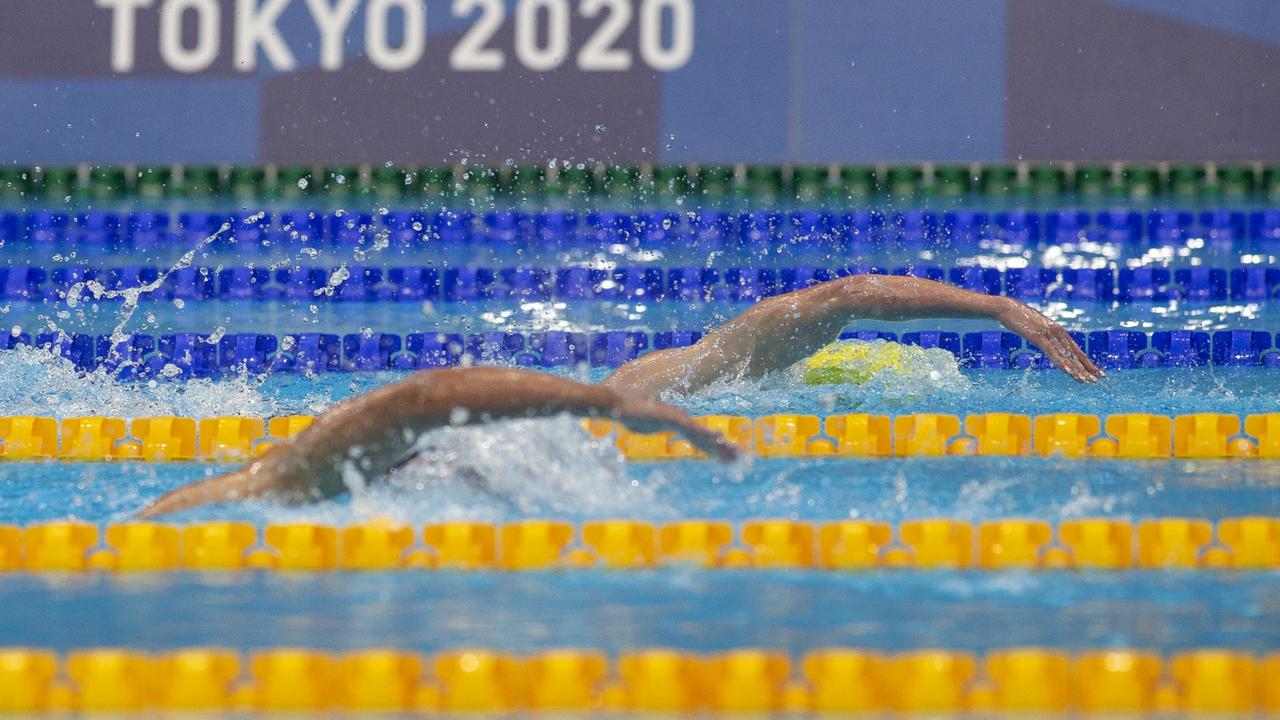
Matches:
[[0, 413, 1280, 461]]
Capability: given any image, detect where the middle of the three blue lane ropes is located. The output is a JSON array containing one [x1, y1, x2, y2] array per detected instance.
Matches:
[[10, 265, 1280, 302]]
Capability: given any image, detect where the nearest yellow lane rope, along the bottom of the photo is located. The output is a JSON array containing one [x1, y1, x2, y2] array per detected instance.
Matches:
[[0, 647, 1280, 716]]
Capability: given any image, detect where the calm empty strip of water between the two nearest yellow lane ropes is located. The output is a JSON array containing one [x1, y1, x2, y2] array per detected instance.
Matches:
[[0, 570, 1280, 653]]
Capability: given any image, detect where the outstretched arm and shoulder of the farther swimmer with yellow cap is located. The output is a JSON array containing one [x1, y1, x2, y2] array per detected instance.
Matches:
[[604, 275, 1102, 396]]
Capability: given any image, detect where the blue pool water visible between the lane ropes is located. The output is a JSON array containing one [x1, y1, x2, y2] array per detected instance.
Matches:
[[0, 194, 1280, 696]]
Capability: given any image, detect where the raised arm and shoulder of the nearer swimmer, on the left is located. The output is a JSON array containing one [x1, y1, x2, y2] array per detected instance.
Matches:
[[140, 368, 735, 518]]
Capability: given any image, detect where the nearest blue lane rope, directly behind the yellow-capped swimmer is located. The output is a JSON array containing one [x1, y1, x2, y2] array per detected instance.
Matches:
[[10, 329, 1280, 380]]
